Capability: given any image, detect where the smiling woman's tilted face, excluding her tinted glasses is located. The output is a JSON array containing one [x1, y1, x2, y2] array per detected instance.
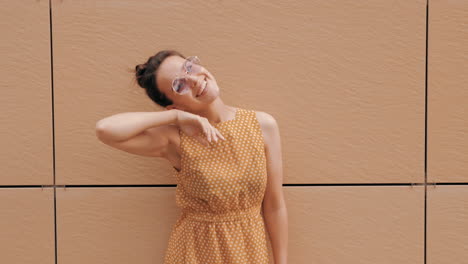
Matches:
[[156, 55, 219, 111]]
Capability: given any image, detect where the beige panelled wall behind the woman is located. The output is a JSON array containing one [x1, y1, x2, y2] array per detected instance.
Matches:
[[0, 0, 468, 264]]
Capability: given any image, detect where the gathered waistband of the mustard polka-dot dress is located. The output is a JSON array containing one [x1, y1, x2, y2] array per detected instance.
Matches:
[[182, 207, 261, 222]]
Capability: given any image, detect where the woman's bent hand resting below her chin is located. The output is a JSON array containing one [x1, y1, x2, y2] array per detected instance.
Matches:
[[176, 110, 226, 146]]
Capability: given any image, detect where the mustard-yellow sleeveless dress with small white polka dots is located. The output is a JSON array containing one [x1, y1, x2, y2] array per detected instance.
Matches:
[[164, 108, 269, 264]]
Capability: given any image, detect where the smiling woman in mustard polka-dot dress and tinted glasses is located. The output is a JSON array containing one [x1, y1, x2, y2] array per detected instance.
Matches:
[[96, 50, 288, 264]]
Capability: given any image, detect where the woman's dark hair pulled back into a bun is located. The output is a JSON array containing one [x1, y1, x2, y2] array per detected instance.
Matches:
[[135, 50, 185, 107]]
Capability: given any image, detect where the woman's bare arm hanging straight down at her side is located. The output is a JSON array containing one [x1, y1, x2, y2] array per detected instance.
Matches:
[[257, 112, 288, 264]]
